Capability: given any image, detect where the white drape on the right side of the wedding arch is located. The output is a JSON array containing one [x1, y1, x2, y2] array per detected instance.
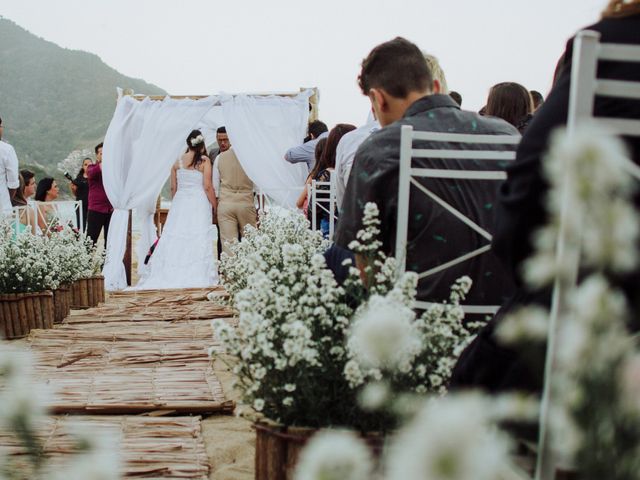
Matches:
[[222, 91, 311, 208]]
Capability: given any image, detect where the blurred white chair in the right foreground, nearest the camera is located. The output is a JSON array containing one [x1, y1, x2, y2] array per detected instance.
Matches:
[[535, 30, 640, 480]]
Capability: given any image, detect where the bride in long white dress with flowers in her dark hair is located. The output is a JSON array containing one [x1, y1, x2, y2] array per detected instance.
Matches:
[[135, 130, 218, 290]]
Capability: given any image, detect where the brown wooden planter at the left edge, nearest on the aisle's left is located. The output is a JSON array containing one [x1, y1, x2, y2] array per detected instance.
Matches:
[[0, 291, 54, 339]]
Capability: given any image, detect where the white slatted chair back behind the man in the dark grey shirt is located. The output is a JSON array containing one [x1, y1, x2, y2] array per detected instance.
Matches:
[[395, 125, 520, 314]]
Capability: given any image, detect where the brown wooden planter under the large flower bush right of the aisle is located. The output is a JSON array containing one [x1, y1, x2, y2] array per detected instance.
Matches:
[[253, 423, 385, 480]]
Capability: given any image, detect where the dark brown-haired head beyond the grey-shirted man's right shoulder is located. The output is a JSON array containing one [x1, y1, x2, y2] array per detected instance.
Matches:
[[484, 82, 533, 133]]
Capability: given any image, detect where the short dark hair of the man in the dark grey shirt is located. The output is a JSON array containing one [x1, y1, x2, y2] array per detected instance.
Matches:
[[358, 37, 433, 98]]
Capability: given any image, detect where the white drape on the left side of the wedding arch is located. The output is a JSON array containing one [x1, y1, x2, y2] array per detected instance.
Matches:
[[102, 96, 217, 290]]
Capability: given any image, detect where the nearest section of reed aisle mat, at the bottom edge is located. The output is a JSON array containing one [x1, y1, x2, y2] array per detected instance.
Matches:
[[0, 416, 210, 480]]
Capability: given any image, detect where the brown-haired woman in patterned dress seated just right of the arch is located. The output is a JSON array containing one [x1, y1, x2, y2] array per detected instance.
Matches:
[[298, 123, 356, 238]]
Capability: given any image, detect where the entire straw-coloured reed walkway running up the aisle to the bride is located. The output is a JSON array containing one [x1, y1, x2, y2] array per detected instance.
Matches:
[[0, 288, 245, 479]]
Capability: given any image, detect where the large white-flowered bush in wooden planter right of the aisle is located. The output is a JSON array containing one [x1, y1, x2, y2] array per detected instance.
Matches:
[[214, 204, 470, 479]]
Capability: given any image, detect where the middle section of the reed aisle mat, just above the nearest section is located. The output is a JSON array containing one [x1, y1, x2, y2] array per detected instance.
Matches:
[[29, 321, 235, 415]]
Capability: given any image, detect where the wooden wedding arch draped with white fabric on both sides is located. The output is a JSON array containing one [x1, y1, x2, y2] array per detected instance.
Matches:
[[102, 89, 318, 291]]
